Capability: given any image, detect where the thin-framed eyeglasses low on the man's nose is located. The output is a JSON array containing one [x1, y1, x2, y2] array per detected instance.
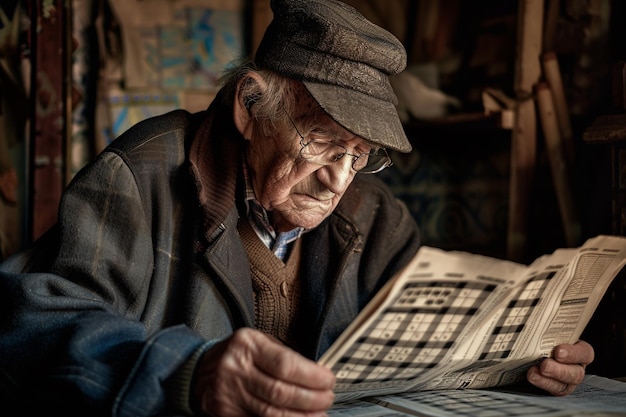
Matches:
[[285, 112, 393, 174]]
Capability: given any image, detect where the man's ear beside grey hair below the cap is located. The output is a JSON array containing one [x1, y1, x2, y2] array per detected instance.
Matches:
[[233, 72, 265, 140]]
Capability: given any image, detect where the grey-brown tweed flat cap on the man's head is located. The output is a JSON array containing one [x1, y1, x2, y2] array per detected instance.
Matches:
[[255, 0, 411, 152]]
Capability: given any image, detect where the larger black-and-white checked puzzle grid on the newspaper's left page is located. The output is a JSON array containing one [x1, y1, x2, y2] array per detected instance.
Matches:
[[333, 281, 495, 384]]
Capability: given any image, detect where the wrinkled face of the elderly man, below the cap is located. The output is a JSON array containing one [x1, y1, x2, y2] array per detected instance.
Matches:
[[247, 86, 364, 231]]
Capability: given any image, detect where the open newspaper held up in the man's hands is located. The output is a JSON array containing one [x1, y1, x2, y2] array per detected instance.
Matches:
[[319, 236, 626, 401]]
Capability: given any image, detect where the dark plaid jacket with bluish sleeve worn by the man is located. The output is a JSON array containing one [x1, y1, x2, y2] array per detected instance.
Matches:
[[0, 97, 419, 416]]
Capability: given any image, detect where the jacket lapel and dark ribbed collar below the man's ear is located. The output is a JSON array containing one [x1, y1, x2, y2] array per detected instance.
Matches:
[[189, 96, 254, 327]]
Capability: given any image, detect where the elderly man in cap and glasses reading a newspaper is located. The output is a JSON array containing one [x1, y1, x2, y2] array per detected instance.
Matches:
[[0, 0, 593, 416]]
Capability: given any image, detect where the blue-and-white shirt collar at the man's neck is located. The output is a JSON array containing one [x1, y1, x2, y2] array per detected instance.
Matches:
[[243, 158, 304, 261]]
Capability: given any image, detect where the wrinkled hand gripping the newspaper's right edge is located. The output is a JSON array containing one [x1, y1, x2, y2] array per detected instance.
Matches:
[[526, 341, 594, 397]]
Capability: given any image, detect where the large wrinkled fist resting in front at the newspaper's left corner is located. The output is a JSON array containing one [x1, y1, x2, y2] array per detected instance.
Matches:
[[194, 328, 335, 417]]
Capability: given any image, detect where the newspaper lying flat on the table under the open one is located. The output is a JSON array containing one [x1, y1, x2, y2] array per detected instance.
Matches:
[[328, 375, 626, 417]]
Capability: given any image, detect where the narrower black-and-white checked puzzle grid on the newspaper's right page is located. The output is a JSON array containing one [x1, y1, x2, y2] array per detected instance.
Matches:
[[479, 272, 555, 360]]
